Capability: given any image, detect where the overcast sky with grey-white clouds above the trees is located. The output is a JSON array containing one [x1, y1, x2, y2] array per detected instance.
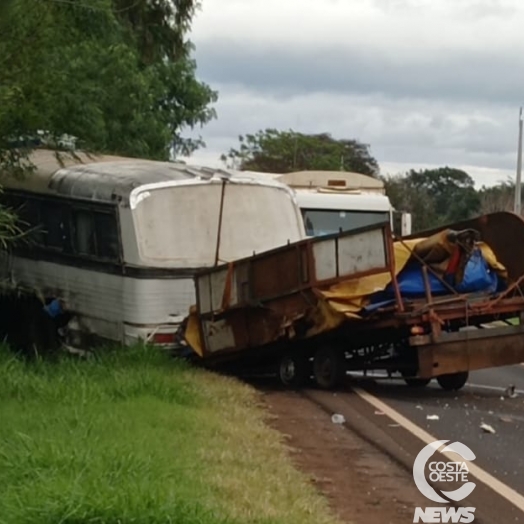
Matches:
[[181, 0, 524, 185]]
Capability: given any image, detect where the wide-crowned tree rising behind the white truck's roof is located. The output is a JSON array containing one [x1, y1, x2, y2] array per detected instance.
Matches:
[[221, 129, 379, 176]]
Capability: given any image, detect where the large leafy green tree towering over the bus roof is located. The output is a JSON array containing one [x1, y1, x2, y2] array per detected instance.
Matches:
[[0, 0, 216, 160]]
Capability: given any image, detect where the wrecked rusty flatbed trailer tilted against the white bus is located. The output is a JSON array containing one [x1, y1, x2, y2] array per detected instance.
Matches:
[[183, 213, 524, 389]]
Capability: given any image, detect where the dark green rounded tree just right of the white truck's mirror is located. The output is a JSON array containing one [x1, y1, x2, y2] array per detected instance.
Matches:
[[385, 167, 481, 231]]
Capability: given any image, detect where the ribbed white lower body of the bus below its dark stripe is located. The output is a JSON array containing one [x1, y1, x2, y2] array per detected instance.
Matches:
[[0, 255, 195, 342]]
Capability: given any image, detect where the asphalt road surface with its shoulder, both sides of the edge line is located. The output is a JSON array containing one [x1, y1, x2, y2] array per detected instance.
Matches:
[[248, 365, 524, 524]]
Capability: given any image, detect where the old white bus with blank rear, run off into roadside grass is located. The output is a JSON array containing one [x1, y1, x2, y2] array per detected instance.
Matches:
[[0, 150, 305, 347]]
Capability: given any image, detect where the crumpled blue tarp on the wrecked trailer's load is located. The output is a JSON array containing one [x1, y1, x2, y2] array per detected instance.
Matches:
[[363, 249, 504, 314]]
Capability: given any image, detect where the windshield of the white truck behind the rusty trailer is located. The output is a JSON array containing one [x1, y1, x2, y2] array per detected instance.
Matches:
[[302, 209, 389, 236]]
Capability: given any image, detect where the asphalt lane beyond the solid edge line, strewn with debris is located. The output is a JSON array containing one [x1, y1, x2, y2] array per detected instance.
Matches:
[[350, 365, 524, 522]]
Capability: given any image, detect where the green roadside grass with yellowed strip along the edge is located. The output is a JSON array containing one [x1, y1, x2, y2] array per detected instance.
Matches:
[[0, 347, 334, 524]]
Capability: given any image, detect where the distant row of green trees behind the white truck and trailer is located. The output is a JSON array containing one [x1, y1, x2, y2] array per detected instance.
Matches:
[[221, 129, 515, 232]]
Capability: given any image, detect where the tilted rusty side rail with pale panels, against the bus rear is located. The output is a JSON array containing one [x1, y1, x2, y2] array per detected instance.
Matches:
[[195, 223, 395, 357]]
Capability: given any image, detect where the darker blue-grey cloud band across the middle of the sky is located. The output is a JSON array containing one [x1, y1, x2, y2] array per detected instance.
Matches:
[[196, 41, 524, 105]]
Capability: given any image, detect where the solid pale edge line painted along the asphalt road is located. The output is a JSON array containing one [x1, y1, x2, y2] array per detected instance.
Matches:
[[352, 387, 524, 512]]
